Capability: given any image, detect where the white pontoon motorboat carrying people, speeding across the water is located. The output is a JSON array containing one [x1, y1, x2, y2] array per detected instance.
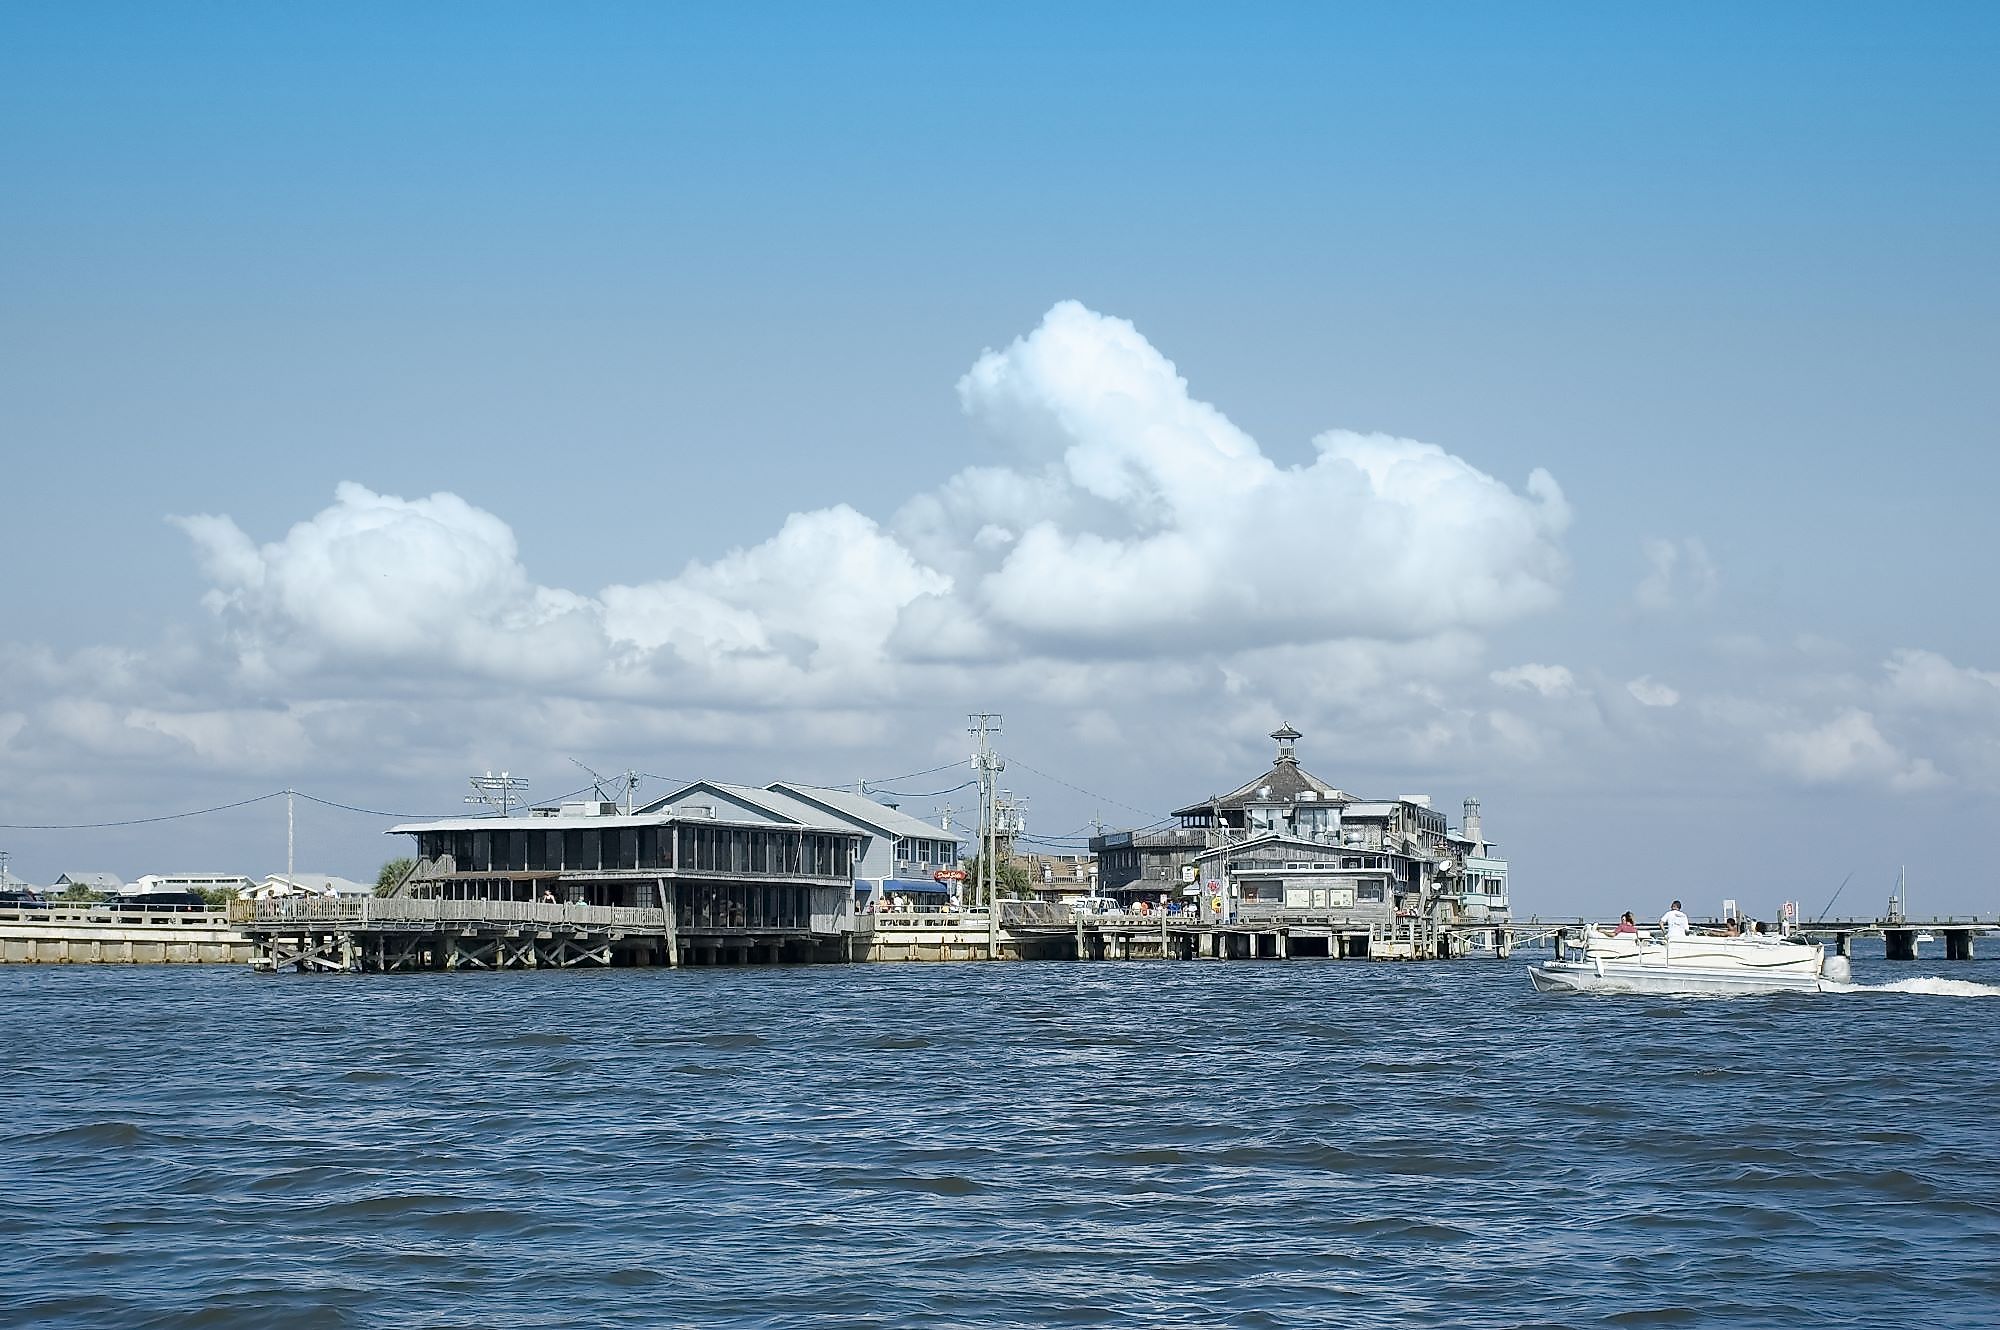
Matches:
[[1528, 926, 1848, 994]]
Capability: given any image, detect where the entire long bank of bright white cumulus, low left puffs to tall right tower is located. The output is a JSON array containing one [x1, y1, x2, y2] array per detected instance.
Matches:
[[176, 302, 1568, 704]]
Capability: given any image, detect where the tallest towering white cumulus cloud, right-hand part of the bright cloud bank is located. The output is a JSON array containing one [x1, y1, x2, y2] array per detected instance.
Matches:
[[936, 302, 1570, 652]]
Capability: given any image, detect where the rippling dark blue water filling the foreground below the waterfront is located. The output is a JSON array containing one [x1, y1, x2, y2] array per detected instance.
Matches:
[[0, 958, 2000, 1328]]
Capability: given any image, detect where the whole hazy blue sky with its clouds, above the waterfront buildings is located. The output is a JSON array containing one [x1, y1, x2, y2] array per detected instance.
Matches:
[[0, 4, 2000, 912]]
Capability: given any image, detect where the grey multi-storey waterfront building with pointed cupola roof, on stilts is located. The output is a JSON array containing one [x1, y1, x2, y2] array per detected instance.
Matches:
[[1092, 726, 1508, 954]]
